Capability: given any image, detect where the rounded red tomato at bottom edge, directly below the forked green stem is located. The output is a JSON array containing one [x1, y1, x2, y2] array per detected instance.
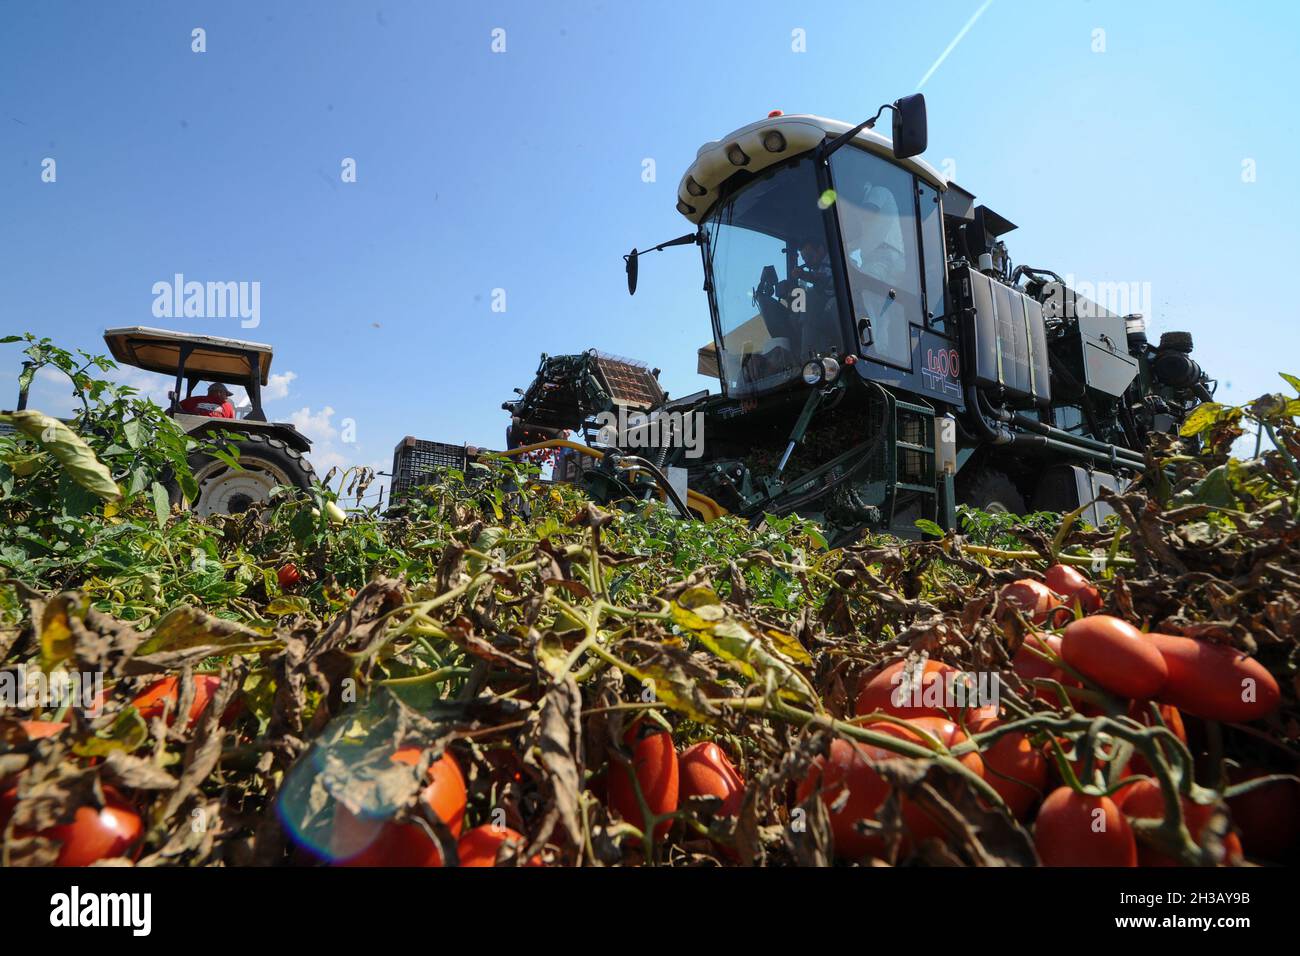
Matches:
[[1034, 787, 1138, 866]]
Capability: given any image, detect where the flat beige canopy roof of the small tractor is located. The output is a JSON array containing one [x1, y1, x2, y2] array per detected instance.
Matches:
[[104, 325, 270, 385]]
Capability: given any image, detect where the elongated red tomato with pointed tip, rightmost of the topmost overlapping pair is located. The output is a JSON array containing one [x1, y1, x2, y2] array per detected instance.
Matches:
[[1147, 633, 1282, 723]]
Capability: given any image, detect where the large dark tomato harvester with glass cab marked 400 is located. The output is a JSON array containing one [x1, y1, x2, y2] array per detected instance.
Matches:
[[465, 94, 1216, 542]]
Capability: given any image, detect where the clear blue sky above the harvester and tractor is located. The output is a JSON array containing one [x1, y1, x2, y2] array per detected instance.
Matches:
[[0, 0, 1300, 502]]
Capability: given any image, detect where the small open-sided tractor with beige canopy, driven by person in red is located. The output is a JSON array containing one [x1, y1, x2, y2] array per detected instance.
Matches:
[[104, 326, 315, 515]]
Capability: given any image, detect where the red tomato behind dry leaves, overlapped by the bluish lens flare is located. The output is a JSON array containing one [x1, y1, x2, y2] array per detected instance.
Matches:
[[333, 747, 468, 866]]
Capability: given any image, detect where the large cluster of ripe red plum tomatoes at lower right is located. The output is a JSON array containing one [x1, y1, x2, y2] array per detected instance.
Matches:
[[797, 564, 1300, 866]]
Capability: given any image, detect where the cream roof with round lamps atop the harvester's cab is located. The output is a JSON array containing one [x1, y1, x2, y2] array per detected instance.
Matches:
[[677, 113, 948, 222]]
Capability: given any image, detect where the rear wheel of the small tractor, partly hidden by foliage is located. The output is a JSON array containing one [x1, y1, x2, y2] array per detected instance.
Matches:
[[169, 433, 316, 516]]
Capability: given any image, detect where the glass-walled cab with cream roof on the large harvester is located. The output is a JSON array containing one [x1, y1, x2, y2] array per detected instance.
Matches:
[[677, 116, 948, 397]]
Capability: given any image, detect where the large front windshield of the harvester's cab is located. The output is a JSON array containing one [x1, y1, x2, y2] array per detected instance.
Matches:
[[705, 157, 845, 395]]
